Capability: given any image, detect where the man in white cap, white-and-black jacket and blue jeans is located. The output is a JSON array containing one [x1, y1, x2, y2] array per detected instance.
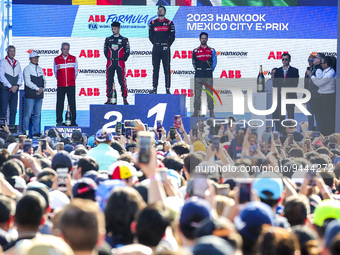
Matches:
[[23, 51, 46, 134]]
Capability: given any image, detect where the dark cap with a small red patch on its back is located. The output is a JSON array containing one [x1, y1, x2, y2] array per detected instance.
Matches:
[[72, 177, 97, 200]]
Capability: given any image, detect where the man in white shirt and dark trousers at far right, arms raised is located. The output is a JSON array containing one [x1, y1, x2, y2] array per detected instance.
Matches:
[[311, 56, 336, 135]]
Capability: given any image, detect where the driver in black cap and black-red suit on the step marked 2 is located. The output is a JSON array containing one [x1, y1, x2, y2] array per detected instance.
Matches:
[[104, 22, 130, 105]]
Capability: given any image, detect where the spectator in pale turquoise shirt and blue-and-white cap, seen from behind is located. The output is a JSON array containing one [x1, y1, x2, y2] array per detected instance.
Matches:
[[87, 129, 119, 171]]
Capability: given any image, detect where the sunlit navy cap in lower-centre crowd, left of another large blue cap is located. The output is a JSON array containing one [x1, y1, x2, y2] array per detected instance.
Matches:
[[179, 197, 211, 228]]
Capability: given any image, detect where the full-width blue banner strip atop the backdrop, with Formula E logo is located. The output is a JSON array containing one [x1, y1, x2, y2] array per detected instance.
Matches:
[[13, 5, 337, 39]]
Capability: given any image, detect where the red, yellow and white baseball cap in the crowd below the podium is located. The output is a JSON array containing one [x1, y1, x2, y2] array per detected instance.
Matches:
[[107, 160, 143, 180]]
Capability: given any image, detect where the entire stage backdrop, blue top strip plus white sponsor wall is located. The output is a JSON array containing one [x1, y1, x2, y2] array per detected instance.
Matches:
[[12, 4, 337, 126]]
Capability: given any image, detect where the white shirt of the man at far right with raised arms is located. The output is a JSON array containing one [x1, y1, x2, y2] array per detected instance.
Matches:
[[311, 67, 335, 94]]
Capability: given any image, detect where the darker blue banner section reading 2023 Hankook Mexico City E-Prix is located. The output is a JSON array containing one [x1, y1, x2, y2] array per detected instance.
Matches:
[[174, 7, 337, 39]]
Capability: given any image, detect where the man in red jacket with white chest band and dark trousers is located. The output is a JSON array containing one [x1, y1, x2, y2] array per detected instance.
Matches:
[[54, 42, 78, 126]]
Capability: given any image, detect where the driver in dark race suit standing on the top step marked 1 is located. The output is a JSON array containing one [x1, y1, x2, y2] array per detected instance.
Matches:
[[149, 5, 175, 94]]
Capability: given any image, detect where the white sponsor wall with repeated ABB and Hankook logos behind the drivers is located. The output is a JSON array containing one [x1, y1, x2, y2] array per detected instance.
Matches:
[[12, 37, 336, 110]]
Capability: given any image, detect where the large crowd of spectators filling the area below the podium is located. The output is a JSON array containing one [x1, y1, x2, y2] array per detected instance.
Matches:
[[0, 111, 340, 255]]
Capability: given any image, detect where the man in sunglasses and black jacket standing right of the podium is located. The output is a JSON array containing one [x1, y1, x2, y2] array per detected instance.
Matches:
[[273, 53, 299, 132]]
